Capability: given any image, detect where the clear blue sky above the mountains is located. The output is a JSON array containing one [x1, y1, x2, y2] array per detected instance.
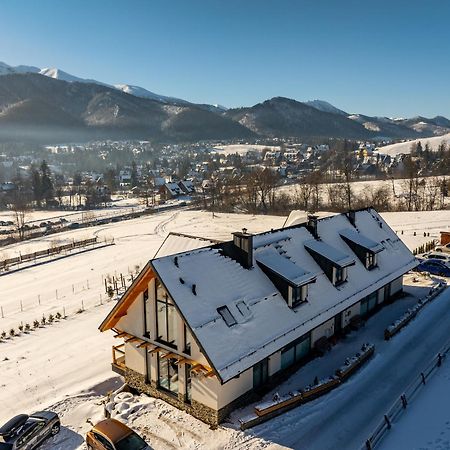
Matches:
[[0, 0, 450, 116]]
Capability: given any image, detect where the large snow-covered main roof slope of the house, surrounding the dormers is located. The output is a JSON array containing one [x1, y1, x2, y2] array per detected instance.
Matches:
[[151, 209, 417, 382]]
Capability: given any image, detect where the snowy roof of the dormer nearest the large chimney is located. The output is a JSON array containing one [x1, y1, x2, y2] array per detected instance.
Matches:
[[255, 246, 315, 286]]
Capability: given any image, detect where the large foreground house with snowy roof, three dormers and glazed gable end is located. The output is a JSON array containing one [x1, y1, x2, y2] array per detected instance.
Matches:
[[100, 208, 417, 425]]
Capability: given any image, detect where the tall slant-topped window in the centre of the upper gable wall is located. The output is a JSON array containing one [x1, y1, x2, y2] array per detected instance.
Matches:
[[156, 281, 177, 348]]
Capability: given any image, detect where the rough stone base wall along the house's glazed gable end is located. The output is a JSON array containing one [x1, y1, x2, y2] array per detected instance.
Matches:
[[124, 368, 223, 426]]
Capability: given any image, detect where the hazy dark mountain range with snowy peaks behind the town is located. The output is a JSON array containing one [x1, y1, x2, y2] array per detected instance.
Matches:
[[0, 62, 450, 142]]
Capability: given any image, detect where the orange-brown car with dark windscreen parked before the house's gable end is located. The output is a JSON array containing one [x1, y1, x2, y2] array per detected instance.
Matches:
[[86, 419, 151, 450]]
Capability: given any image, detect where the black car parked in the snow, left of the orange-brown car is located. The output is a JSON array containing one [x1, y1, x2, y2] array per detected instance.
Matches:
[[0, 411, 61, 450]]
